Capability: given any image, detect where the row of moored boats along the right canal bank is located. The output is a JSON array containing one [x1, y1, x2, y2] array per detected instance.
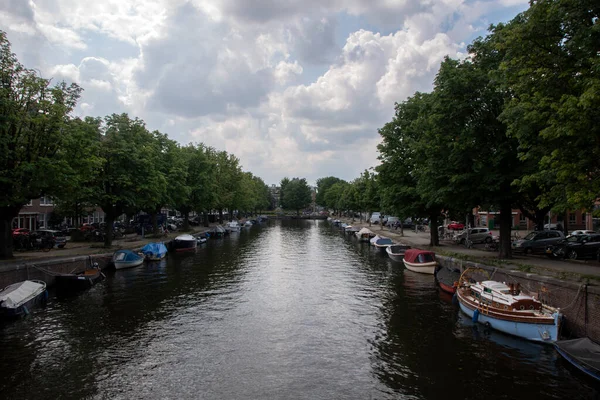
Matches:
[[332, 220, 600, 381]]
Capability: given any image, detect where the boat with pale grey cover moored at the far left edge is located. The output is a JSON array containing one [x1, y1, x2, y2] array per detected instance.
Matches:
[[0, 280, 48, 318]]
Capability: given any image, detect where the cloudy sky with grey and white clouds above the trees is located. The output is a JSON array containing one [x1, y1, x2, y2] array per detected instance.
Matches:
[[0, 0, 528, 185]]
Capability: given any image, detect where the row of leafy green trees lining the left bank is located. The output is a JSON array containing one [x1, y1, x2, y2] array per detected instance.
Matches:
[[0, 32, 270, 258]]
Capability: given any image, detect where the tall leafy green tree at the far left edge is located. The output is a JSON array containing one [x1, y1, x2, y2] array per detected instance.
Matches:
[[0, 31, 81, 258]]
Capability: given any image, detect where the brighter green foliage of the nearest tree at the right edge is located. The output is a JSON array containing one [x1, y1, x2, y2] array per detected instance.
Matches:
[[500, 0, 600, 209]]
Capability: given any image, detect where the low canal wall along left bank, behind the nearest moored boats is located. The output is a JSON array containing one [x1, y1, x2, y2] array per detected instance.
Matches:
[[0, 254, 112, 288]]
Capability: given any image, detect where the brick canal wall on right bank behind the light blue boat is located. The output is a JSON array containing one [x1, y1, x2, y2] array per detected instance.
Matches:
[[436, 255, 600, 342]]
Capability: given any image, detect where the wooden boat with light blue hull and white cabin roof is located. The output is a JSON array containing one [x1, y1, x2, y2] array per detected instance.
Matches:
[[456, 268, 562, 343]]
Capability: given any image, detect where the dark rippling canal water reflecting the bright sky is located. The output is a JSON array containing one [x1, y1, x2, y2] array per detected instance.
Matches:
[[0, 220, 598, 400]]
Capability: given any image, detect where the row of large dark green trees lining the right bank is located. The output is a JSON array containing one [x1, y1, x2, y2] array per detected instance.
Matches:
[[317, 0, 600, 258]]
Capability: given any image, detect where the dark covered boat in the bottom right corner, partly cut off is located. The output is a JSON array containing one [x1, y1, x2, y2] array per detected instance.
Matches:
[[554, 337, 600, 381]]
